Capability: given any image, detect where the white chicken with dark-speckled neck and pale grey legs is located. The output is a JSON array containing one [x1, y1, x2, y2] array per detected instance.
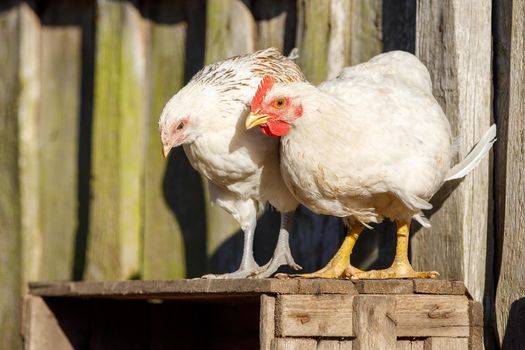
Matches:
[[159, 48, 304, 278]]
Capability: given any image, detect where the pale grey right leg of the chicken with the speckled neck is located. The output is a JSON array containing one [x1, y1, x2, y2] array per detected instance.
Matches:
[[254, 212, 301, 278]]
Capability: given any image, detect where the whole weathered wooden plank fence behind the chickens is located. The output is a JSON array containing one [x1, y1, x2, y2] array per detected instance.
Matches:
[[0, 0, 525, 349]]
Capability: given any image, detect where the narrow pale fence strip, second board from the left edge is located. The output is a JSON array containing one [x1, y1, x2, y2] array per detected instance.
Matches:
[[18, 3, 43, 292]]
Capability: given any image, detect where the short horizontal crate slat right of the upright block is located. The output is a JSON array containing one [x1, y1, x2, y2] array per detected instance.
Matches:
[[395, 295, 470, 337]]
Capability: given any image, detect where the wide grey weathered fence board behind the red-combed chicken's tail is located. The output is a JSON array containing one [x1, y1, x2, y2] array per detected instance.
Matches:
[[412, 0, 491, 301]]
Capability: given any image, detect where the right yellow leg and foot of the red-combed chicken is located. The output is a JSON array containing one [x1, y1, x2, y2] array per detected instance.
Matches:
[[351, 221, 439, 280]]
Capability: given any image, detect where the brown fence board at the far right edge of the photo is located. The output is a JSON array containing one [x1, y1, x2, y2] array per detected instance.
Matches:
[[495, 0, 525, 349]]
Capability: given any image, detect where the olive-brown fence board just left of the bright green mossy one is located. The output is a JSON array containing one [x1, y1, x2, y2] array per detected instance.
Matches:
[[38, 1, 87, 279]]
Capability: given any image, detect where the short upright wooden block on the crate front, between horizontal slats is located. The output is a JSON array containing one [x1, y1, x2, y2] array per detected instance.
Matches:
[[352, 295, 396, 350]]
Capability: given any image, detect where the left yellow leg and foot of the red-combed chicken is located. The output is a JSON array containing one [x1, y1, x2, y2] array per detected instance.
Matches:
[[275, 224, 364, 278]]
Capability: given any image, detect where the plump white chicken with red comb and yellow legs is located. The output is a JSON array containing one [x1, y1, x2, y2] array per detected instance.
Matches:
[[246, 51, 496, 279]]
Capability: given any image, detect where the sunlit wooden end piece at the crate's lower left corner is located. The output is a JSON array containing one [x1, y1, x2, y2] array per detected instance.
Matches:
[[22, 296, 74, 350]]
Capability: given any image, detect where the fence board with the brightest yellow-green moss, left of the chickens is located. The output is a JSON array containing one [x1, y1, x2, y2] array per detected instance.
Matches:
[[85, 1, 146, 280]]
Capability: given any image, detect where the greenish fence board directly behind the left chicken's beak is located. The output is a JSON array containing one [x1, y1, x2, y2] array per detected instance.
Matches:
[[143, 1, 186, 279]]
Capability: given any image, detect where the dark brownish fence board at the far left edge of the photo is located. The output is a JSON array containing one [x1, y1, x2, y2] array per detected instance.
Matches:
[[0, 1, 21, 349]]
